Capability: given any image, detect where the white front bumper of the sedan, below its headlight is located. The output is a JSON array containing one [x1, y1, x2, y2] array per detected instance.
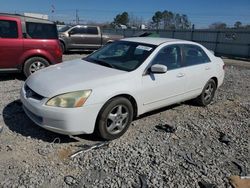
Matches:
[[20, 87, 102, 135]]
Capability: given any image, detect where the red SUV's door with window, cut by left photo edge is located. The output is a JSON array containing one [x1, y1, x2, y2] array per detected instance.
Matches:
[[0, 17, 23, 69]]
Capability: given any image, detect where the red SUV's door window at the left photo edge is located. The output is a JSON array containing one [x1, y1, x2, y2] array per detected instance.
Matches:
[[0, 20, 18, 38]]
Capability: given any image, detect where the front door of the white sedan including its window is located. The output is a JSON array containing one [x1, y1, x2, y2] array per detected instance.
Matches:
[[141, 45, 187, 113]]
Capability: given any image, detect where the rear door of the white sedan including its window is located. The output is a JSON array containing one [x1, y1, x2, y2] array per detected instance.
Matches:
[[182, 44, 213, 98]]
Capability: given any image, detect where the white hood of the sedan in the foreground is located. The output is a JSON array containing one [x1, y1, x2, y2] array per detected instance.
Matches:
[[26, 59, 127, 97]]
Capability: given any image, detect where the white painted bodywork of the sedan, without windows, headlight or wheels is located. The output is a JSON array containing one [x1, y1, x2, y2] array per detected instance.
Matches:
[[20, 38, 224, 135]]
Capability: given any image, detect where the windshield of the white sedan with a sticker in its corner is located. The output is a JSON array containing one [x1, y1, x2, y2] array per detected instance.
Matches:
[[84, 41, 156, 71]]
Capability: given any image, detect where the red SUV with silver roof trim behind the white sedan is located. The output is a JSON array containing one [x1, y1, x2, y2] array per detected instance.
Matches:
[[0, 13, 62, 77]]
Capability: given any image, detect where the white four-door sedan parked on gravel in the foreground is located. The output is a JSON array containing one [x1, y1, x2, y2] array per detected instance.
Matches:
[[21, 37, 224, 140]]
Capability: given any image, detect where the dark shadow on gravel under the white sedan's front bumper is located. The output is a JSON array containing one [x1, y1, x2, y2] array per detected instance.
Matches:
[[2, 100, 101, 143]]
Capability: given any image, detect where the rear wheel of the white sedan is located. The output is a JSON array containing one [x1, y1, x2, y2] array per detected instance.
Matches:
[[195, 79, 217, 106]]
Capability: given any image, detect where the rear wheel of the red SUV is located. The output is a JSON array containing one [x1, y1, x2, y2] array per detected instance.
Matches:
[[23, 57, 50, 77]]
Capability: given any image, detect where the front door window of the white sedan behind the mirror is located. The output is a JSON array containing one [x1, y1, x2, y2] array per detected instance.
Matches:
[[152, 45, 181, 70]]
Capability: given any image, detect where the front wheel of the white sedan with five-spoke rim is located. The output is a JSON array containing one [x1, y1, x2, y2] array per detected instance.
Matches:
[[96, 97, 133, 140]]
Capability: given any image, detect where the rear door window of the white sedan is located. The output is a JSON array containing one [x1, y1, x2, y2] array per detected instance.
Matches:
[[183, 45, 210, 66]]
